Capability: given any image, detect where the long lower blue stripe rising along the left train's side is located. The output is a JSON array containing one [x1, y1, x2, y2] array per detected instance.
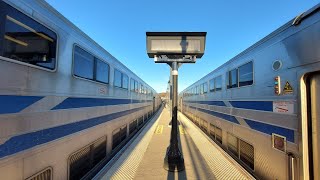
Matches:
[[0, 106, 146, 158]]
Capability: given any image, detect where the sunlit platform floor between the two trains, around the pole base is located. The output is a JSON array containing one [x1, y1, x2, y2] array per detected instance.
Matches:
[[96, 108, 254, 180]]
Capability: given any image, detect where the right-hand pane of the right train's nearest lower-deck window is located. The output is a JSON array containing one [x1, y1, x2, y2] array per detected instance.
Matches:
[[240, 139, 254, 169]]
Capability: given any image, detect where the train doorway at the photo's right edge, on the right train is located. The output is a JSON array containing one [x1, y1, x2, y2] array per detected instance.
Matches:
[[307, 72, 320, 180]]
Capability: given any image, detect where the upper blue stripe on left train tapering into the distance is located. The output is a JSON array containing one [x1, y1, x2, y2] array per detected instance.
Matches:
[[52, 97, 150, 110]]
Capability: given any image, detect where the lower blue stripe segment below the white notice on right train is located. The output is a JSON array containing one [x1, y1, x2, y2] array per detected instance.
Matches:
[[245, 119, 294, 143]]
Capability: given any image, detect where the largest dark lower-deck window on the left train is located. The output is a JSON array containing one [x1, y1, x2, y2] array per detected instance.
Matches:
[[68, 136, 107, 180]]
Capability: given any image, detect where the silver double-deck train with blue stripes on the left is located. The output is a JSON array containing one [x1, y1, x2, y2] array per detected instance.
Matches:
[[0, 0, 161, 180]]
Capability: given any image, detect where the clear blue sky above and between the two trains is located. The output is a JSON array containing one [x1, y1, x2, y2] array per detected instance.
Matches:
[[47, 0, 319, 92]]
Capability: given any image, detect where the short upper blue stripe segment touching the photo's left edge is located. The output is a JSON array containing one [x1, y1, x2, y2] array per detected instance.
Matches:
[[0, 95, 43, 114]]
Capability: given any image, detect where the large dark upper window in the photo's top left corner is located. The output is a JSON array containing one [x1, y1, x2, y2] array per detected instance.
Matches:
[[0, 2, 57, 70]]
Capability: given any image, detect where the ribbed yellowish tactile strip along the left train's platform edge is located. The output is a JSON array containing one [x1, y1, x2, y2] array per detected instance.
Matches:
[[101, 111, 163, 180]]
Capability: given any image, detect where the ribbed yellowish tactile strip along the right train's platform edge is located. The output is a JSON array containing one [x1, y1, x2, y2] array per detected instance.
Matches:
[[178, 113, 254, 180]]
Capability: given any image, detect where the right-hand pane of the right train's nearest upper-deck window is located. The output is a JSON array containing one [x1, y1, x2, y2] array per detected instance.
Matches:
[[239, 61, 253, 87]]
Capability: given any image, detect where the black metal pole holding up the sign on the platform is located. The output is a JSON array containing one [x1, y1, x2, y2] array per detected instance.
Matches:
[[164, 62, 184, 171]]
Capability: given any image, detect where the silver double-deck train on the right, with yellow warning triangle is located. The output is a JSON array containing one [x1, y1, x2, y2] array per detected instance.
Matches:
[[179, 5, 320, 180]]
